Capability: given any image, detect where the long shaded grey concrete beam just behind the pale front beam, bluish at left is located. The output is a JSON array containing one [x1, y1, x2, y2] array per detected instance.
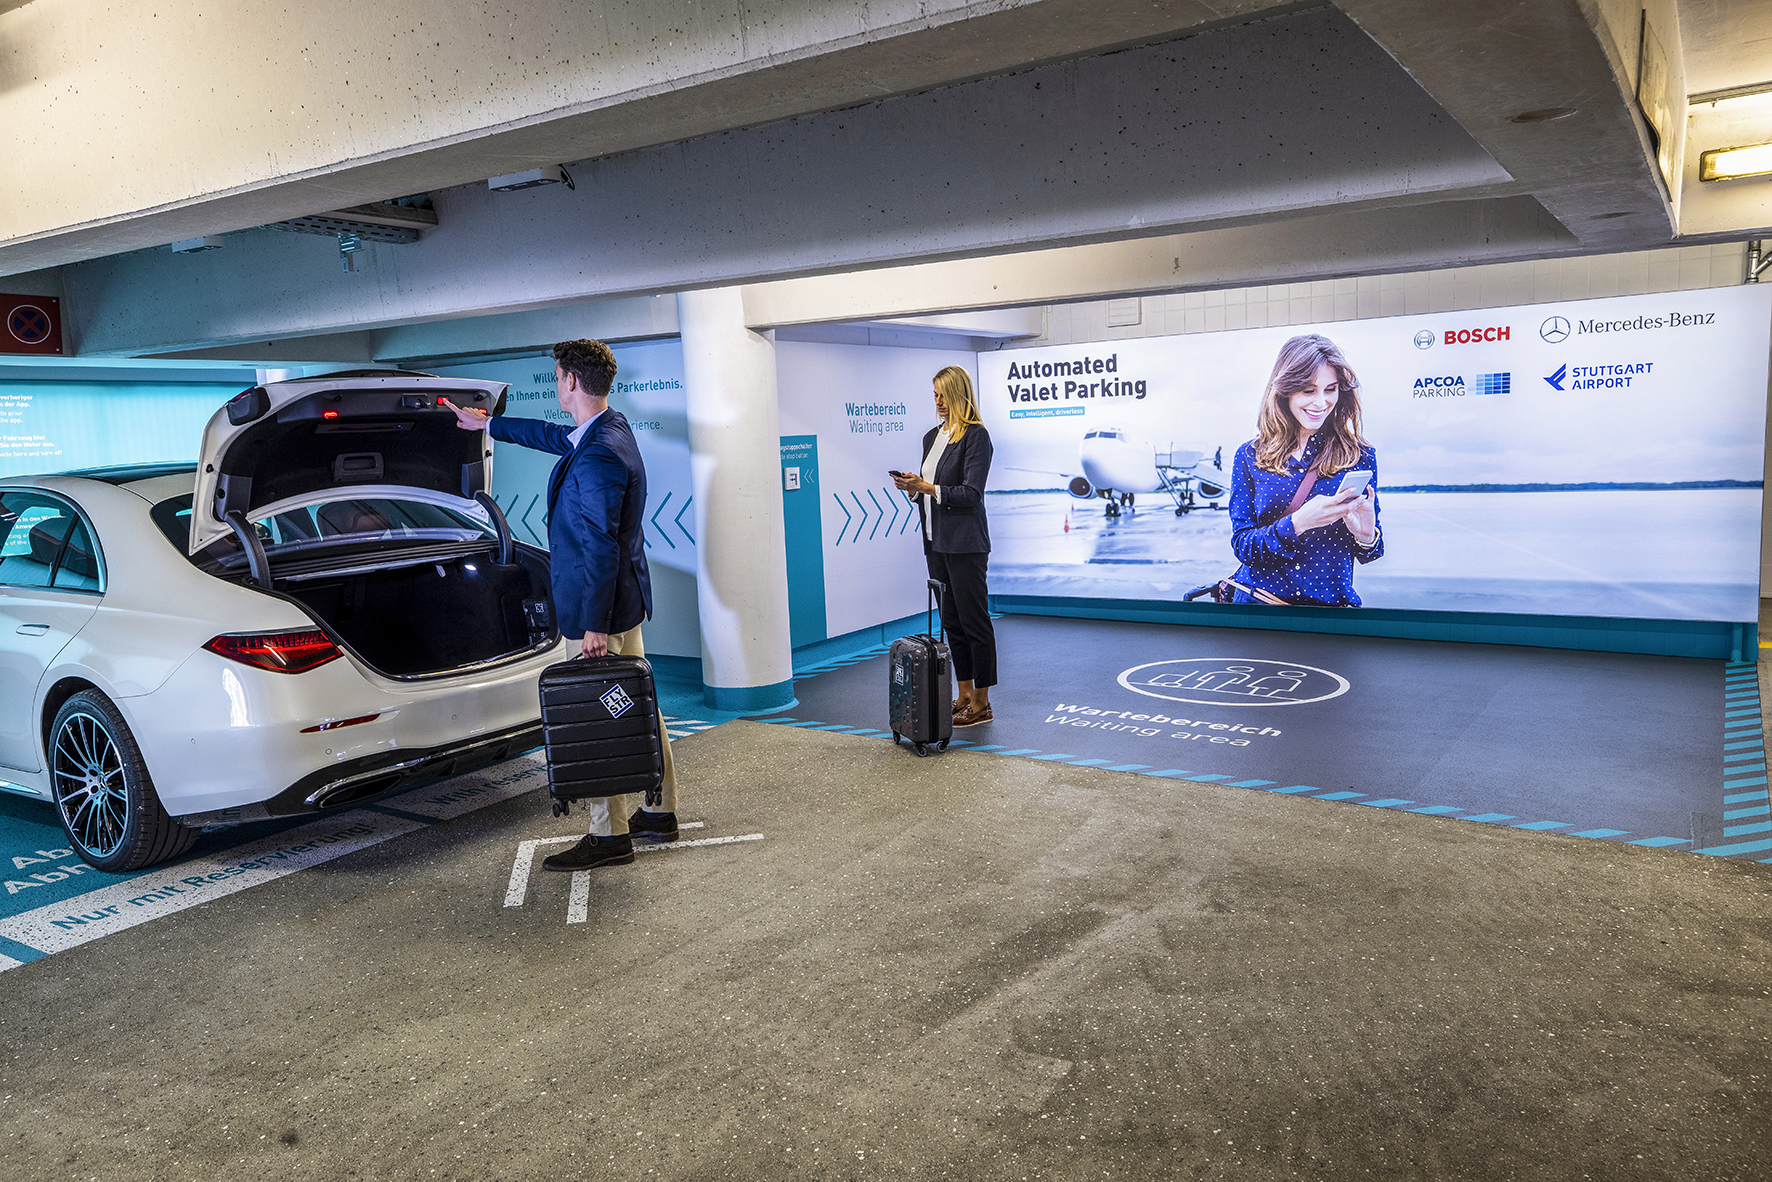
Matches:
[[66, 9, 1519, 354]]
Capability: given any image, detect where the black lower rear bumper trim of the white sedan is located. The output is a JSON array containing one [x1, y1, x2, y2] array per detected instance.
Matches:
[[175, 719, 542, 828]]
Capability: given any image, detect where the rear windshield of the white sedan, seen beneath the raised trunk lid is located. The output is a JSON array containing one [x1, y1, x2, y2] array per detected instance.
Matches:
[[149, 493, 498, 562]]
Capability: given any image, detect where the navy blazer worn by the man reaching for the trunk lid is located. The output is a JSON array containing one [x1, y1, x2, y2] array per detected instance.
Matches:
[[487, 409, 652, 640]]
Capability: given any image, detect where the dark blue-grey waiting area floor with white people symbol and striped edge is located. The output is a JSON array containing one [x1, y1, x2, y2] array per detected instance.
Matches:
[[779, 615, 1772, 861]]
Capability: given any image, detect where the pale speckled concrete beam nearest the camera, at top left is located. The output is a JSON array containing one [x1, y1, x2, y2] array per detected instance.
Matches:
[[0, 0, 1283, 275]]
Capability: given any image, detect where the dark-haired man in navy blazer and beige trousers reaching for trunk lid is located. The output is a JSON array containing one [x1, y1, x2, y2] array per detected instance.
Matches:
[[445, 340, 677, 870]]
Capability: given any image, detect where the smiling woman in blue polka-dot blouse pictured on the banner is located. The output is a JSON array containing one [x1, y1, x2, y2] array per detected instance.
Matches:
[[1230, 333, 1384, 608]]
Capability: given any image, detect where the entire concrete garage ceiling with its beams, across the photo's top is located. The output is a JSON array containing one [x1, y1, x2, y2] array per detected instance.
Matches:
[[0, 0, 1772, 354]]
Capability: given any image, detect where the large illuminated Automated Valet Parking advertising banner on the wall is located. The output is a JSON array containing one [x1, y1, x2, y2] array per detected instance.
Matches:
[[978, 287, 1772, 622]]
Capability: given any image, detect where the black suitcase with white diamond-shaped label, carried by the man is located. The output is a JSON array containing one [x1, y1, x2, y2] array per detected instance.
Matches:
[[540, 656, 665, 817]]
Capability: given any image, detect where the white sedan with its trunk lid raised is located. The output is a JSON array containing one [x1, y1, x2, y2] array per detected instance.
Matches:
[[0, 370, 569, 872]]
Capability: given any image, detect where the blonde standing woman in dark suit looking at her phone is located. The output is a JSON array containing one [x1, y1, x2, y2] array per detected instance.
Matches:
[[893, 365, 996, 727]]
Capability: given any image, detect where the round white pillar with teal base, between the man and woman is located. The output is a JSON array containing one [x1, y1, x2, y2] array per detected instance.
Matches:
[[677, 287, 794, 711]]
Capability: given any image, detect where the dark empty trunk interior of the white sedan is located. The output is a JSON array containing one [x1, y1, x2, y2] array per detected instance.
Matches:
[[278, 548, 555, 677]]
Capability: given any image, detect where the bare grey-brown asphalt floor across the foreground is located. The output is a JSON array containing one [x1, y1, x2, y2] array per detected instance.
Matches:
[[0, 721, 1772, 1182]]
